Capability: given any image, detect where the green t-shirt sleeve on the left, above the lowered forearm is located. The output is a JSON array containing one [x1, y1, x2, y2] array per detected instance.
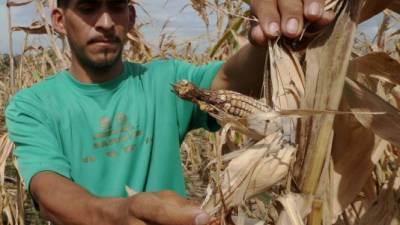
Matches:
[[5, 92, 70, 189]]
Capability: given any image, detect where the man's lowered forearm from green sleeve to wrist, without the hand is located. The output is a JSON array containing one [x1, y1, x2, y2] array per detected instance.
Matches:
[[30, 172, 122, 225]]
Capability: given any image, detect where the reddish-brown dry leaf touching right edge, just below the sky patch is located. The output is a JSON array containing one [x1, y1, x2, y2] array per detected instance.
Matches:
[[349, 52, 400, 85]]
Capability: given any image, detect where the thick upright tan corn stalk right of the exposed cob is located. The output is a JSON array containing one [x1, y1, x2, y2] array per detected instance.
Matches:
[[298, 0, 364, 225]]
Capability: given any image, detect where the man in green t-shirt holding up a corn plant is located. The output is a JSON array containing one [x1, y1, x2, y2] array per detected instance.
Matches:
[[6, 0, 336, 225]]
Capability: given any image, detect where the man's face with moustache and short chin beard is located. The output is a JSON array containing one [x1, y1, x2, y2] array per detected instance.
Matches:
[[55, 0, 134, 69]]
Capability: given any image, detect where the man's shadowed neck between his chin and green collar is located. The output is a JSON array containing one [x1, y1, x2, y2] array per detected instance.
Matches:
[[70, 59, 123, 83]]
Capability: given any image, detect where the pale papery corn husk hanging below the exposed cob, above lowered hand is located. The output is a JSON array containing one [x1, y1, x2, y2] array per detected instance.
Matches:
[[203, 133, 295, 215]]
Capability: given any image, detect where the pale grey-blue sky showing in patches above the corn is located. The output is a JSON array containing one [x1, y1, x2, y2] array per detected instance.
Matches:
[[0, 0, 382, 53]]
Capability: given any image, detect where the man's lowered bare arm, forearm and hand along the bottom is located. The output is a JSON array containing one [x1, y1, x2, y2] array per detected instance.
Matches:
[[30, 172, 210, 225]]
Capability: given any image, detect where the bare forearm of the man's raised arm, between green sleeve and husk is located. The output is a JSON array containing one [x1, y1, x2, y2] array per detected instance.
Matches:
[[211, 44, 266, 97]]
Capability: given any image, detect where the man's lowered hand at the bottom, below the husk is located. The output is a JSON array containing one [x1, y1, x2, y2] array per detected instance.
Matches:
[[101, 191, 210, 225]]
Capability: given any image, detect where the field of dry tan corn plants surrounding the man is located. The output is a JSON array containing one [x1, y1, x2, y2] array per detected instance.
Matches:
[[0, 0, 400, 225]]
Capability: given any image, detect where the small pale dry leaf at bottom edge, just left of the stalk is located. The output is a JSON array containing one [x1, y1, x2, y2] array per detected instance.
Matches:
[[276, 193, 312, 225]]
